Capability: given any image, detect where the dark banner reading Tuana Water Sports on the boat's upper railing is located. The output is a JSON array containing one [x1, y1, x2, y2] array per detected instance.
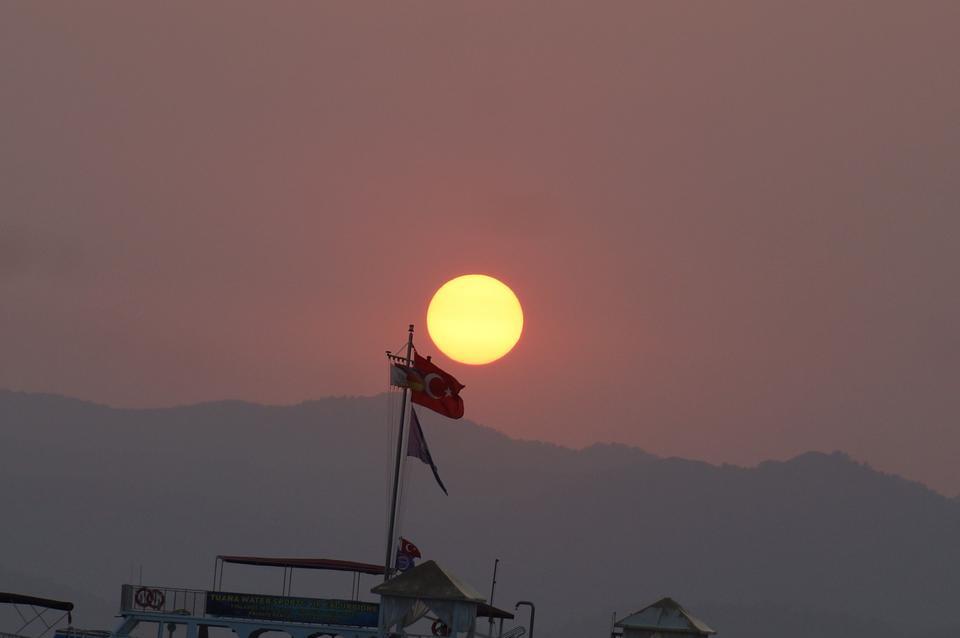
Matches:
[[205, 591, 380, 627]]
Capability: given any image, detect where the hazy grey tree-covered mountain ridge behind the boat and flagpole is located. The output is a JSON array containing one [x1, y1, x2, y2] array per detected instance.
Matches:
[[0, 391, 960, 638]]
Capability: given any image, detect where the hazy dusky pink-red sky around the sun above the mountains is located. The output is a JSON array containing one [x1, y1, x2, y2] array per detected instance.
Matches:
[[0, 0, 960, 494]]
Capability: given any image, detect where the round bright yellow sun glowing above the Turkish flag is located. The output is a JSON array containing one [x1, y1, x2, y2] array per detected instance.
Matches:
[[427, 275, 523, 365]]
